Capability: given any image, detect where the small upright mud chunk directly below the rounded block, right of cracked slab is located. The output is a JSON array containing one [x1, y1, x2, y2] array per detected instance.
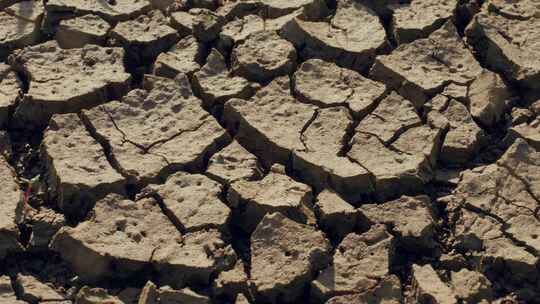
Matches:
[[428, 99, 485, 164]]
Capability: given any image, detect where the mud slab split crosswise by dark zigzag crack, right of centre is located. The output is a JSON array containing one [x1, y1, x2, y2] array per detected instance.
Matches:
[[347, 92, 443, 200]]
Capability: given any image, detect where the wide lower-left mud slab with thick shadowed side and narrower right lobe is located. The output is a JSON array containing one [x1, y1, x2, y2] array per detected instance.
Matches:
[[51, 195, 235, 286]]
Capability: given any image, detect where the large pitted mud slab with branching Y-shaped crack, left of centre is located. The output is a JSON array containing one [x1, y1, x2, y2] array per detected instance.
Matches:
[[83, 75, 230, 182]]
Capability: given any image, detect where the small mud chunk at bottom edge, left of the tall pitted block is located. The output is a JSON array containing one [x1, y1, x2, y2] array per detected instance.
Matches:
[[213, 260, 249, 298]]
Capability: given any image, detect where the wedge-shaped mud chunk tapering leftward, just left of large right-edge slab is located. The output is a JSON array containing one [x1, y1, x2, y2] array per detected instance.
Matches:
[[359, 196, 436, 251]]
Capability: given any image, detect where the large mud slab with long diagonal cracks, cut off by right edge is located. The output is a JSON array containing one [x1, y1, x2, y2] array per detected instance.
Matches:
[[447, 138, 540, 294]]
